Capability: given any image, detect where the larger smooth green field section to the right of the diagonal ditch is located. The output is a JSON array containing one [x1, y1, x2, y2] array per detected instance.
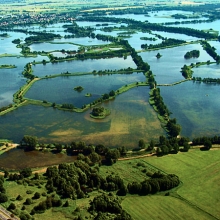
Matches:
[[148, 149, 220, 219]]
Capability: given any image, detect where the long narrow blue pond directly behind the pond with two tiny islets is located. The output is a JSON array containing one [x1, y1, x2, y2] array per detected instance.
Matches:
[[32, 56, 136, 77]]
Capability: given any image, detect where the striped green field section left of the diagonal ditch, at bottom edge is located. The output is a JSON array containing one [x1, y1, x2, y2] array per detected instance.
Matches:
[[122, 195, 212, 220]]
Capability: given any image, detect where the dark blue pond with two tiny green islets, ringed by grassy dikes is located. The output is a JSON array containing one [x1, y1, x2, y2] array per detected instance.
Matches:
[[25, 73, 146, 108]]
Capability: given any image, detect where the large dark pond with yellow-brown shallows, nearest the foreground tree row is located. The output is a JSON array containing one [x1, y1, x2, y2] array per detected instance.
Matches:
[[0, 87, 164, 147]]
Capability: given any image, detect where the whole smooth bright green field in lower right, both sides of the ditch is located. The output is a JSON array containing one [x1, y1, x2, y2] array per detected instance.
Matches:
[[124, 149, 220, 219]]
